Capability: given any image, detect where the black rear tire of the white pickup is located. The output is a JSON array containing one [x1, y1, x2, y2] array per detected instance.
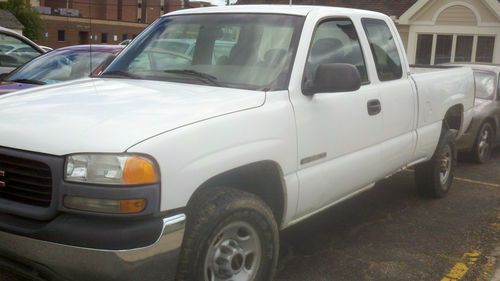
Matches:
[[415, 129, 457, 198]]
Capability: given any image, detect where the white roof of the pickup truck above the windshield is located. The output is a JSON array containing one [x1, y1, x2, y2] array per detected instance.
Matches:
[[165, 5, 383, 16]]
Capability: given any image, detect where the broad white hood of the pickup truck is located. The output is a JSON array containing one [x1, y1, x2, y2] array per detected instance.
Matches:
[[0, 79, 265, 155]]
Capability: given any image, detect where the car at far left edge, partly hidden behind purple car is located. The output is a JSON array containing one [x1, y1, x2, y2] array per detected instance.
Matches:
[[0, 27, 45, 74]]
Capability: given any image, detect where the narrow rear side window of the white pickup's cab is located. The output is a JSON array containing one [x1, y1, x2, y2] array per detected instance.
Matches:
[[363, 19, 403, 81]]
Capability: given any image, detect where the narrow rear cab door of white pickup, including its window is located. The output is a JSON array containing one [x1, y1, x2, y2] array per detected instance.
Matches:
[[362, 18, 417, 174]]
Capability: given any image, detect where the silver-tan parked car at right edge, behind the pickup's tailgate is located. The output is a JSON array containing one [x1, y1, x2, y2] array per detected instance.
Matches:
[[457, 64, 500, 163]]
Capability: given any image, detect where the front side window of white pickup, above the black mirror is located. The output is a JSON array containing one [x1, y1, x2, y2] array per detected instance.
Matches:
[[305, 19, 368, 83]]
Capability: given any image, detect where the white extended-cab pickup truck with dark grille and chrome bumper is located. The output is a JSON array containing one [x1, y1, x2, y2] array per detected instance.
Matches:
[[0, 6, 474, 281]]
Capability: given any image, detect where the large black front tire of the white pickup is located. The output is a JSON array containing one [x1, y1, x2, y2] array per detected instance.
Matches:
[[176, 187, 279, 281]]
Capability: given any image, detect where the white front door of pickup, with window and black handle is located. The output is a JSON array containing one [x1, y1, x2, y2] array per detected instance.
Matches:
[[290, 17, 384, 218]]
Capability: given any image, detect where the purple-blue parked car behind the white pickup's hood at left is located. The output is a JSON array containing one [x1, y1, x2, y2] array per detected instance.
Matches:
[[0, 45, 123, 95]]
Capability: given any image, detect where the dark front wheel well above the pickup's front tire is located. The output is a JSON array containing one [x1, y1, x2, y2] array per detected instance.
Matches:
[[188, 161, 286, 226]]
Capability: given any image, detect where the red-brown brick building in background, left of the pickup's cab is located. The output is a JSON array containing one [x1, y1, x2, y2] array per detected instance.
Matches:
[[30, 0, 189, 48]]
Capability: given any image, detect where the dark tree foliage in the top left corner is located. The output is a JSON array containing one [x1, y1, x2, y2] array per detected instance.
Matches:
[[0, 0, 43, 40]]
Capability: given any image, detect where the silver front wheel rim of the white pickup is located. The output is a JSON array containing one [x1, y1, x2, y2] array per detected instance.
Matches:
[[204, 221, 262, 281]]
